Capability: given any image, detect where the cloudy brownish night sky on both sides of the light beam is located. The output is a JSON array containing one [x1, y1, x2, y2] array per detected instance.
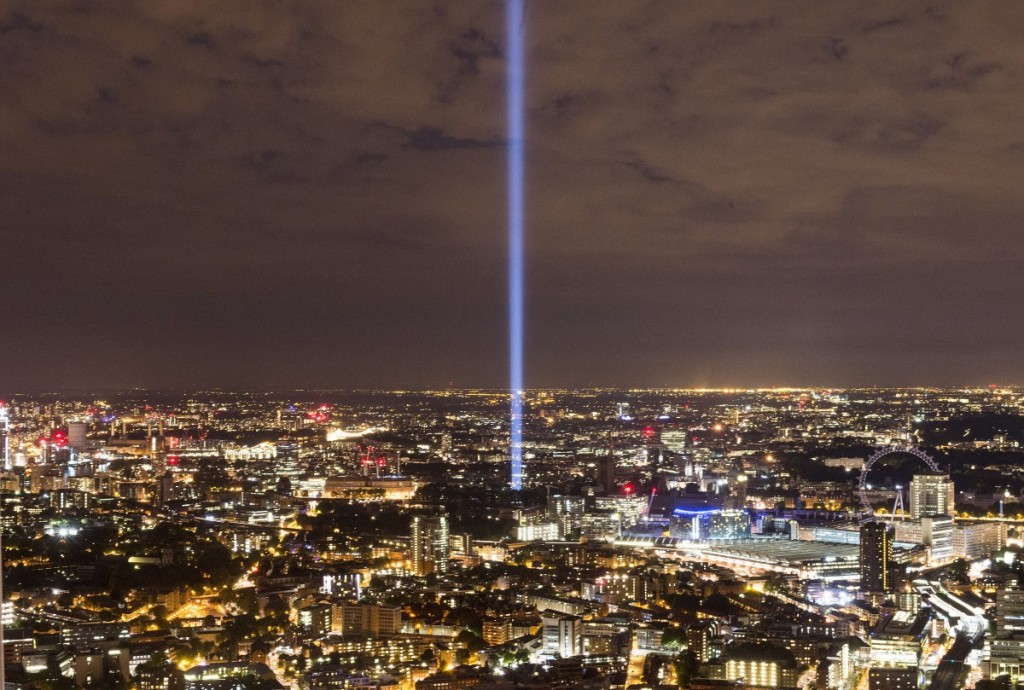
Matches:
[[0, 0, 1024, 386]]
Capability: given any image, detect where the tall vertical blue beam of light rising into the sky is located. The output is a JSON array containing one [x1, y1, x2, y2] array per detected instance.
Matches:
[[505, 0, 525, 491]]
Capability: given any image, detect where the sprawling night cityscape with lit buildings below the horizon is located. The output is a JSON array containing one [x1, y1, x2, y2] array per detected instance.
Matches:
[[0, 388, 1024, 690]]
